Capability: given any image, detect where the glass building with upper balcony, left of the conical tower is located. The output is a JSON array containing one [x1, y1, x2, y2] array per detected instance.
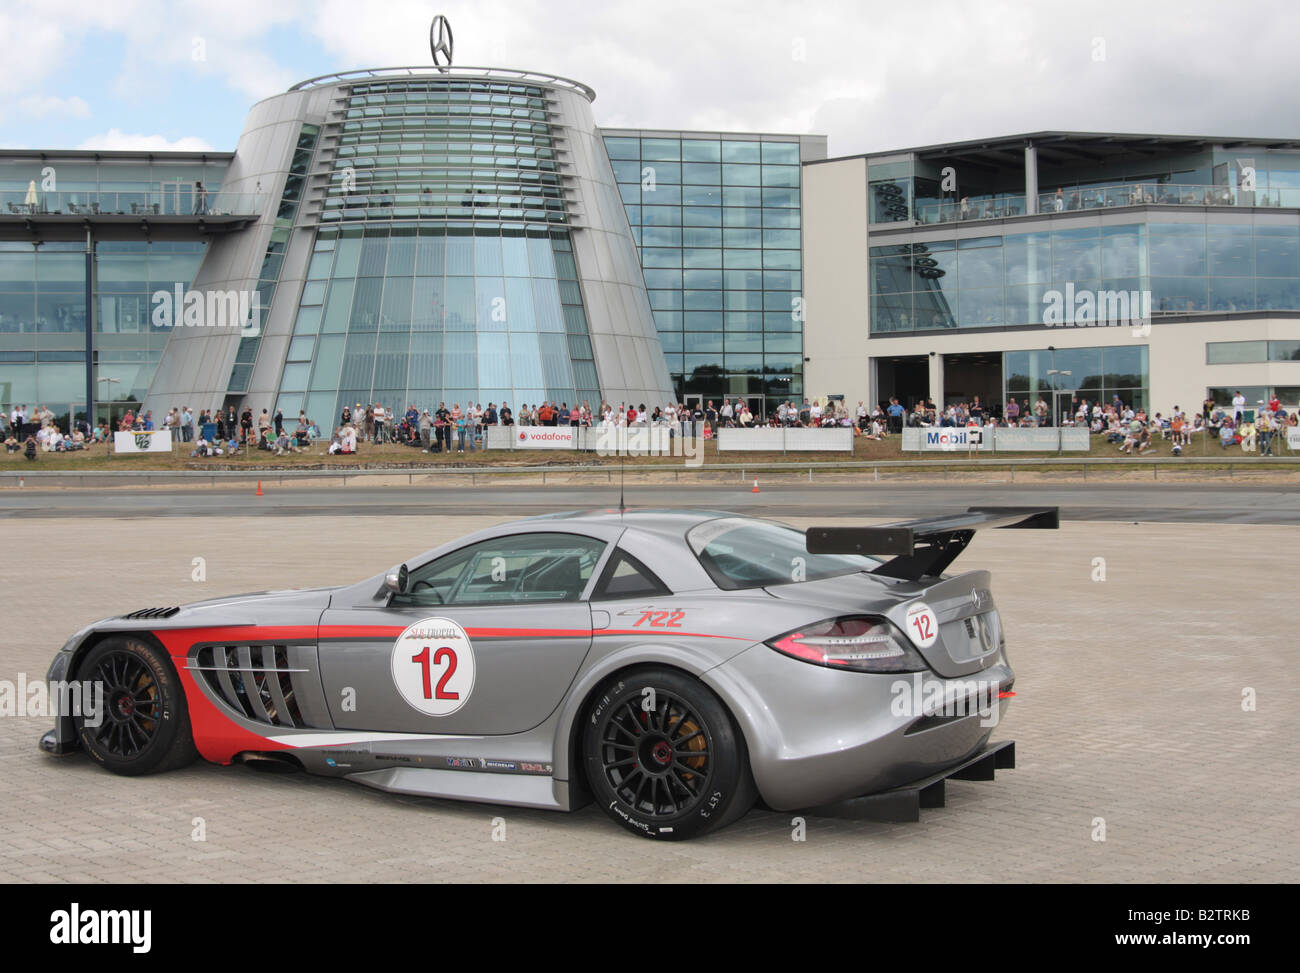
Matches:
[[0, 150, 250, 425]]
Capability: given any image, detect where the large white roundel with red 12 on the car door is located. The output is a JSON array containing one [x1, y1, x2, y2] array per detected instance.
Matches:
[[393, 618, 475, 717]]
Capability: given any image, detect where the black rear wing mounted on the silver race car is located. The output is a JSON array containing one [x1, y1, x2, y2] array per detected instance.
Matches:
[[805, 507, 1061, 581]]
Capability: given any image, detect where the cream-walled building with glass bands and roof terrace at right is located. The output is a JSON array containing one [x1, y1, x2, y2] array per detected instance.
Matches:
[[803, 133, 1300, 415]]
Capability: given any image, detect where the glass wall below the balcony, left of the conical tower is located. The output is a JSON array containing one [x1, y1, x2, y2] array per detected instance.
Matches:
[[0, 241, 205, 419]]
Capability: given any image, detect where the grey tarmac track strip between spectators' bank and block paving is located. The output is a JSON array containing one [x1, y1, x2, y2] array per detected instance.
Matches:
[[0, 480, 1300, 524]]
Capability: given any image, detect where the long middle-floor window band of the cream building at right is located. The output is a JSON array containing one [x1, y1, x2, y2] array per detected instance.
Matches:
[[870, 222, 1300, 333]]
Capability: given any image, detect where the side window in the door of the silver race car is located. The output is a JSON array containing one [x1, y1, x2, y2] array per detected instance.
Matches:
[[390, 533, 606, 607]]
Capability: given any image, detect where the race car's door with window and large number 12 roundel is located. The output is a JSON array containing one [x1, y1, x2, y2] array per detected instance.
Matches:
[[320, 532, 606, 735]]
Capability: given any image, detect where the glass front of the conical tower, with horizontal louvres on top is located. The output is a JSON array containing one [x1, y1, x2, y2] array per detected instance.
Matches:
[[277, 78, 601, 418]]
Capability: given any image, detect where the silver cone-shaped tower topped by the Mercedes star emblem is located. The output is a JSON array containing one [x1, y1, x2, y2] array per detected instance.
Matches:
[[151, 68, 672, 428]]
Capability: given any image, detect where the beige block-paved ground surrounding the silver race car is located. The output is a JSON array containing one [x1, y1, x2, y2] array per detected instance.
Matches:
[[0, 517, 1300, 883]]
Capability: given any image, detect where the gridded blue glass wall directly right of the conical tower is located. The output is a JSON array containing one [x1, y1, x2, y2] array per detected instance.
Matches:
[[605, 135, 803, 412]]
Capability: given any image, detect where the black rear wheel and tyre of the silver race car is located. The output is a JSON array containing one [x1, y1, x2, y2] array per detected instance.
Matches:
[[582, 669, 758, 842]]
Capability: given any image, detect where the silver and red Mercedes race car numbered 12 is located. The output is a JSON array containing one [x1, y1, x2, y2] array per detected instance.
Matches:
[[42, 507, 1057, 839]]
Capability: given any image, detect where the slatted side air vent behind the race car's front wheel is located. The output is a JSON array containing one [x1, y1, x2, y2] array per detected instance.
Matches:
[[190, 645, 313, 727]]
